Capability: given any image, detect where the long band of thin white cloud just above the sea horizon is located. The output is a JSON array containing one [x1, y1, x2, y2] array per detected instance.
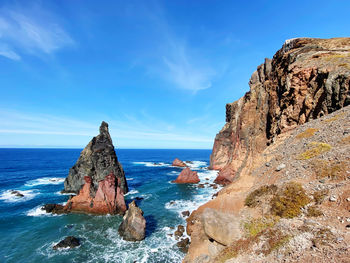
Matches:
[[0, 109, 213, 148]]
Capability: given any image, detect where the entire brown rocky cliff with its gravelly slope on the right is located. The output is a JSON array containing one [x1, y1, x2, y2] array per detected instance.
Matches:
[[184, 38, 350, 263]]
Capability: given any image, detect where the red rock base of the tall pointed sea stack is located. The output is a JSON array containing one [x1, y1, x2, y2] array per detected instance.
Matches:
[[64, 173, 126, 214]]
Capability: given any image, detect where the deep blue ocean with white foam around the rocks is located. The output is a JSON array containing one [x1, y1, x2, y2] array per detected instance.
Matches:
[[0, 149, 218, 263]]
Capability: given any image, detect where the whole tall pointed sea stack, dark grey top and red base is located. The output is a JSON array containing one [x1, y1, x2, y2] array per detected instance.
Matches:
[[64, 121, 128, 214]]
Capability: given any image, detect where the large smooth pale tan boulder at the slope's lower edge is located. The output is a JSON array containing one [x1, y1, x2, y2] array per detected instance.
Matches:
[[202, 208, 242, 246]]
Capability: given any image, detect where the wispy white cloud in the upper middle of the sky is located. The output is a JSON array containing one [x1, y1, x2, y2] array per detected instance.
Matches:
[[142, 1, 216, 93]]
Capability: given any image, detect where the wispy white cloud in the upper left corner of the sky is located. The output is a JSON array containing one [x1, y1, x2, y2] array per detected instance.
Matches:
[[0, 5, 74, 60]]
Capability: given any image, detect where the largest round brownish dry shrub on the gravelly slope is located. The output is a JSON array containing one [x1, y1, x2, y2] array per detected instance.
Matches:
[[270, 182, 310, 218]]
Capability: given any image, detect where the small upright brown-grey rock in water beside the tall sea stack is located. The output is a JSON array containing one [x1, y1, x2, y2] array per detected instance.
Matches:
[[118, 201, 146, 241]]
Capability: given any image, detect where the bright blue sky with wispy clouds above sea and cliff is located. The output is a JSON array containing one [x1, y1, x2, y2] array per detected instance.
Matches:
[[0, 0, 350, 149]]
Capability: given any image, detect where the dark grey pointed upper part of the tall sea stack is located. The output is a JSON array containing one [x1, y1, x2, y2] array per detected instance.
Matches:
[[64, 121, 128, 194]]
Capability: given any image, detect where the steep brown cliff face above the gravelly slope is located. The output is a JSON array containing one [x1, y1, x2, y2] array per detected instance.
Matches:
[[210, 38, 350, 184]]
